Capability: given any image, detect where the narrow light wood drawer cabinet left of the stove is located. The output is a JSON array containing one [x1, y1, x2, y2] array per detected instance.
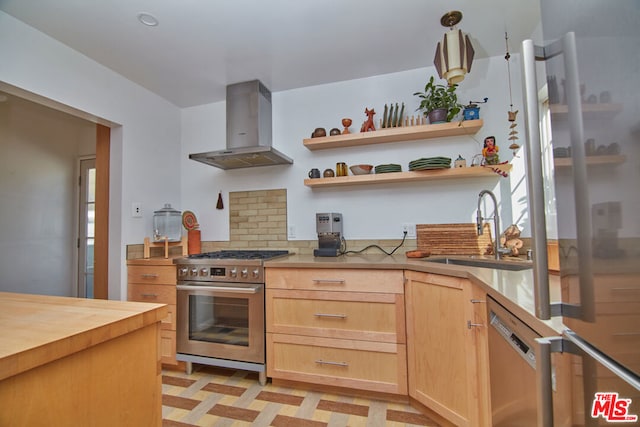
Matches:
[[127, 259, 178, 365]]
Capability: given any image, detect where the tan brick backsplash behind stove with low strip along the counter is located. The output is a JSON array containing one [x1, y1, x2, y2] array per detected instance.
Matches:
[[127, 189, 417, 259]]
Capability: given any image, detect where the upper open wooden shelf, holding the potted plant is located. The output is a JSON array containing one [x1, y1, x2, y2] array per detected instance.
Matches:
[[303, 119, 484, 151]]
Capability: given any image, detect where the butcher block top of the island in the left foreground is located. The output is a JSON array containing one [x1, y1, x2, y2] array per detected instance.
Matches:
[[0, 292, 168, 380]]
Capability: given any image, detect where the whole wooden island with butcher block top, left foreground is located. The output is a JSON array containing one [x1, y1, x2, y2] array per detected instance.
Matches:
[[0, 292, 167, 426]]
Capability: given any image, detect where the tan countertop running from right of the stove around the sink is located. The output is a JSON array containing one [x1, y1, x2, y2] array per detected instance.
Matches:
[[265, 254, 566, 336]]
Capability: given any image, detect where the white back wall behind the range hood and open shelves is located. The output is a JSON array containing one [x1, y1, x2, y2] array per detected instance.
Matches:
[[181, 55, 530, 240]]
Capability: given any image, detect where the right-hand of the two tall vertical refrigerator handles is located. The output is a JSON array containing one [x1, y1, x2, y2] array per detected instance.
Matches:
[[562, 32, 595, 322]]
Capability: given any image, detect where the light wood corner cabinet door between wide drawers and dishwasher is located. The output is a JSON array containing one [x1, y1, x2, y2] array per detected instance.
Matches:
[[405, 271, 491, 426]]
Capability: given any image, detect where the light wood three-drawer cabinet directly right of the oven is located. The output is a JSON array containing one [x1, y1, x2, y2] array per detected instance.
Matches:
[[266, 268, 407, 395]]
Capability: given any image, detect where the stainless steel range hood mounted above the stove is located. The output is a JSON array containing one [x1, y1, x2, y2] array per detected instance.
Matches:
[[189, 80, 293, 169]]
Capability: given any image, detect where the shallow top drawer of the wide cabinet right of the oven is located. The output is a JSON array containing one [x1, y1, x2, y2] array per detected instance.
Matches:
[[265, 267, 404, 294]]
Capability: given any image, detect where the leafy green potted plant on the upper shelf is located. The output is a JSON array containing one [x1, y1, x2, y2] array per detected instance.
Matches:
[[413, 76, 463, 123]]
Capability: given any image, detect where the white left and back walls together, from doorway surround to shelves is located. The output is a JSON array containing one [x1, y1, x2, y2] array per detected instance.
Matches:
[[0, 8, 528, 299]]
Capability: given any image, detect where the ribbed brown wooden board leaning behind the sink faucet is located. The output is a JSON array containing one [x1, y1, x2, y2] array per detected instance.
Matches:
[[416, 223, 493, 256]]
